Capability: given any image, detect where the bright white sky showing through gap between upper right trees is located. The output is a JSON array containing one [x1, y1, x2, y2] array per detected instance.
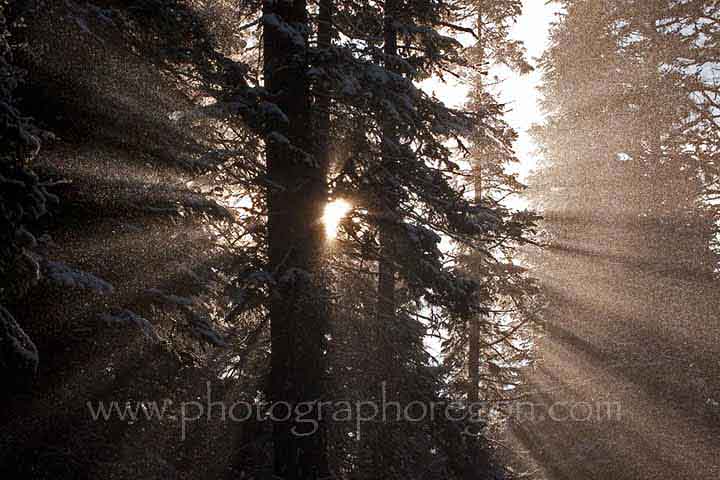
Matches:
[[423, 0, 559, 184]]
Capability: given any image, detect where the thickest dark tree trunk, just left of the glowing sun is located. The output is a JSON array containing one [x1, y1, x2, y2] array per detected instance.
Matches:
[[263, 0, 328, 480]]
